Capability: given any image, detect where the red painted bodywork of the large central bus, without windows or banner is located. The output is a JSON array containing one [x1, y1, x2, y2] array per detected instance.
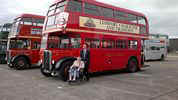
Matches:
[[40, 0, 149, 72]]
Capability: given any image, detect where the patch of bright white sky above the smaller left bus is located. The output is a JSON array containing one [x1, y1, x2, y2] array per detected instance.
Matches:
[[0, 0, 52, 24]]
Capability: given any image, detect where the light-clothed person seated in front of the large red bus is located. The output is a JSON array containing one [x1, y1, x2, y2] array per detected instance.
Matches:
[[69, 57, 84, 81]]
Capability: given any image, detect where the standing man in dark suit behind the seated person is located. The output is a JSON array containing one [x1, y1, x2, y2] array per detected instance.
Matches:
[[80, 44, 90, 81]]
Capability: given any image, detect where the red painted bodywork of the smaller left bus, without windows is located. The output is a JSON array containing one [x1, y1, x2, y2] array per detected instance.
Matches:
[[7, 14, 45, 65]]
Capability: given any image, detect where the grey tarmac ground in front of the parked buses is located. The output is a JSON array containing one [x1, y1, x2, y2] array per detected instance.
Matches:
[[0, 55, 178, 100]]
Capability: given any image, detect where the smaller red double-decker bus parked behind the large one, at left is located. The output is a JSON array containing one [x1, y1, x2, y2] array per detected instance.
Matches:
[[7, 14, 45, 69]]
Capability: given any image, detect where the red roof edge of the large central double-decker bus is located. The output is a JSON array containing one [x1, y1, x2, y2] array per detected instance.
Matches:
[[54, 0, 145, 17]]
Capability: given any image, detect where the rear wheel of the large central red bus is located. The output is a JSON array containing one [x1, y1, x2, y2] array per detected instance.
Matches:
[[127, 59, 138, 73]]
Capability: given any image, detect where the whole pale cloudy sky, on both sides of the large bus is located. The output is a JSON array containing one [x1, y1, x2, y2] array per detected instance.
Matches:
[[0, 0, 178, 37]]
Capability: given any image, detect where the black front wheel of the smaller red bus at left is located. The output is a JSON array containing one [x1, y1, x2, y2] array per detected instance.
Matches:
[[14, 57, 30, 70]]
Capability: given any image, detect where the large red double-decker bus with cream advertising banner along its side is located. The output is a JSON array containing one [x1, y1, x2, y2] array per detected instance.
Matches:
[[40, 0, 149, 79]]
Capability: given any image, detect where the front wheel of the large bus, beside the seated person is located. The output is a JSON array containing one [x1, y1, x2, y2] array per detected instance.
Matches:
[[59, 61, 72, 81]]
